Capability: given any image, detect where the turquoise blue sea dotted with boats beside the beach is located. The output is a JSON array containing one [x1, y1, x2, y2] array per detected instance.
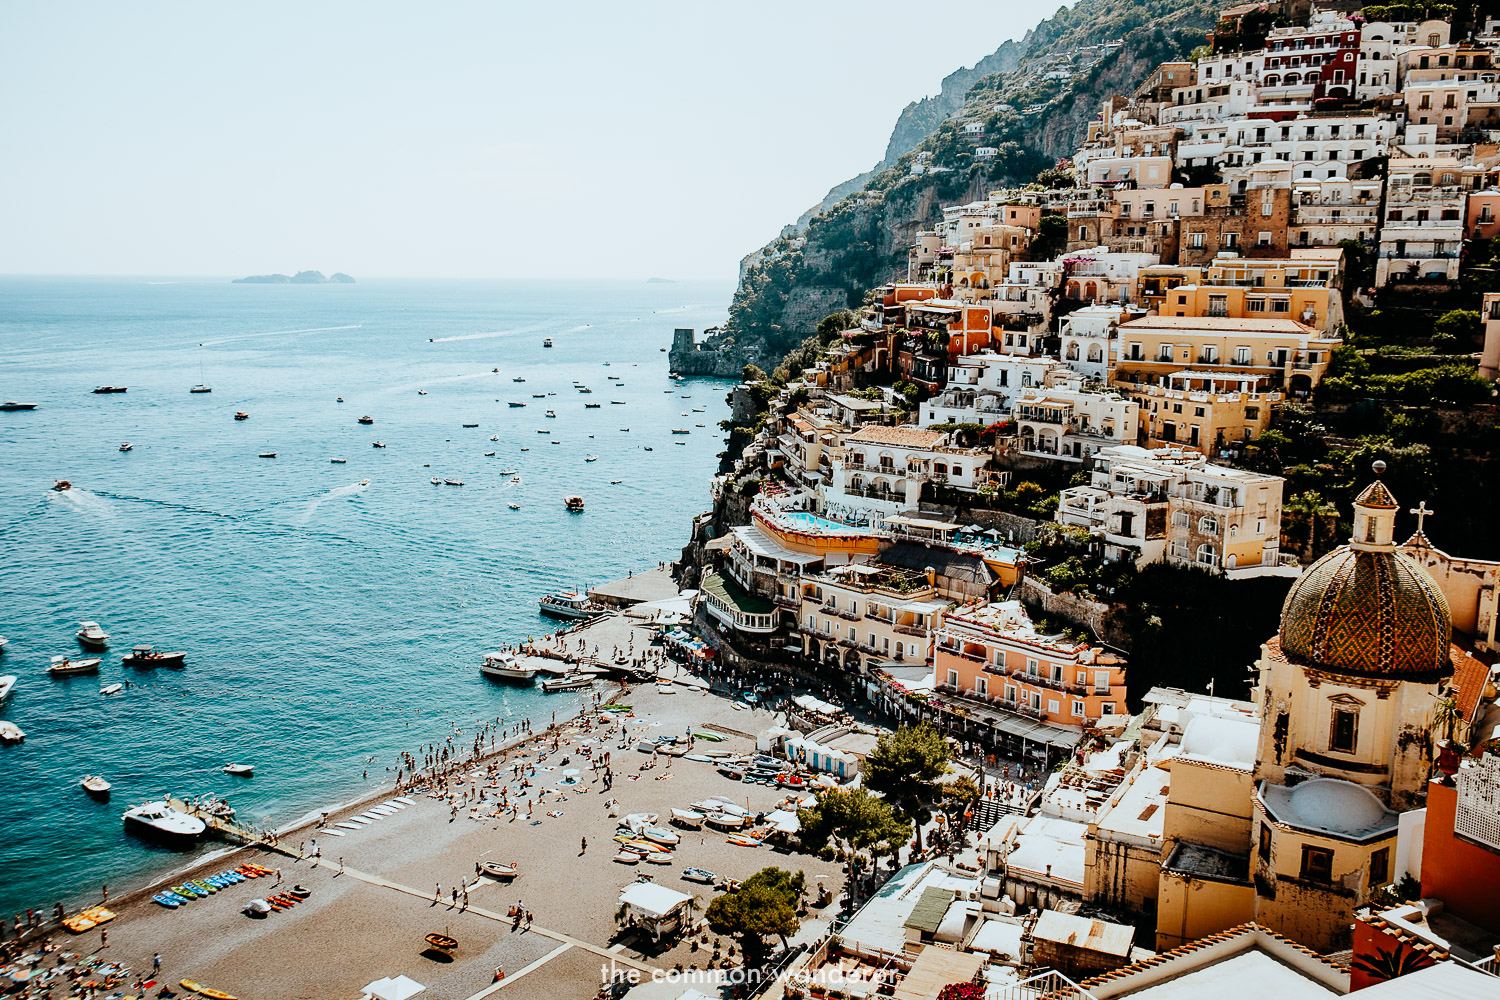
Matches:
[[0, 277, 734, 919]]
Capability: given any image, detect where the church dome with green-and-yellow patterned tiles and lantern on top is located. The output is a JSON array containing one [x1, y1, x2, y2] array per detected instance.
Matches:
[[1281, 481, 1454, 678]]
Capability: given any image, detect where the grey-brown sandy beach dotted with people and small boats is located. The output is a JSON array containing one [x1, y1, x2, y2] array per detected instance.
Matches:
[[38, 678, 842, 1000]]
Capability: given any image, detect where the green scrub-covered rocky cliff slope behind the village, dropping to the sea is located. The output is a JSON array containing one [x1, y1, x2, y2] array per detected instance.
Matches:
[[702, 0, 1217, 372]]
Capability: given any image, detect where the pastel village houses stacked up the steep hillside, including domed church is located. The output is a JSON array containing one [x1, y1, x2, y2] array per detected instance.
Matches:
[[687, 0, 1500, 1000]]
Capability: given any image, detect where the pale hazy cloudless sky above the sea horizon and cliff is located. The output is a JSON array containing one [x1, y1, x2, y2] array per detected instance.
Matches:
[[0, 0, 1056, 279]]
